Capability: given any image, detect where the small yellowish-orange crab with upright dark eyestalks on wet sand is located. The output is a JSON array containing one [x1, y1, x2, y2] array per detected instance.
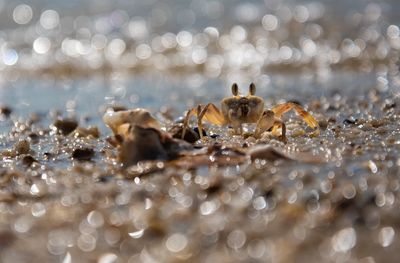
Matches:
[[182, 83, 319, 142]]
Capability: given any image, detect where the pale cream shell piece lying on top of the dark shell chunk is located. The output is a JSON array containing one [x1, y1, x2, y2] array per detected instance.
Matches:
[[103, 108, 160, 134]]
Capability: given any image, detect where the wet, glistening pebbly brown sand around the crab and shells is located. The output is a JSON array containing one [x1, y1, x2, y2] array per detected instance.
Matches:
[[0, 82, 400, 262]]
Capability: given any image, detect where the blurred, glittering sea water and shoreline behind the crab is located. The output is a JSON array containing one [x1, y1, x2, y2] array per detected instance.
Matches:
[[0, 0, 400, 122]]
